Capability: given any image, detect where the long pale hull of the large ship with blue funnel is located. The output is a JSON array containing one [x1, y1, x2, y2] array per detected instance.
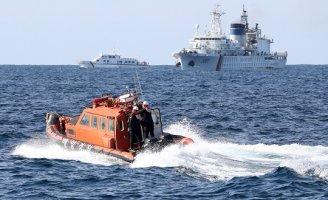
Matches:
[[175, 53, 287, 71]]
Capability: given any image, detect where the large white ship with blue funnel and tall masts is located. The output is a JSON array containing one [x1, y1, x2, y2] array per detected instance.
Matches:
[[173, 6, 287, 71]]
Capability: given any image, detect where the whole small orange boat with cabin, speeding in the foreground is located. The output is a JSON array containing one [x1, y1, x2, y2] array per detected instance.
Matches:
[[46, 91, 193, 162]]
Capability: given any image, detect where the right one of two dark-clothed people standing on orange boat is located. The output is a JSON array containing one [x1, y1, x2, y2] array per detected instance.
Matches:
[[138, 101, 154, 138]]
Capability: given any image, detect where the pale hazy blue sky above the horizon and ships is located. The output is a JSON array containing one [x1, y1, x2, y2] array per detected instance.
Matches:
[[0, 0, 328, 64]]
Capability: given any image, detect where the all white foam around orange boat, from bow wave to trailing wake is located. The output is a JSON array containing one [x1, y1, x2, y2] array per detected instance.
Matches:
[[12, 120, 328, 180]]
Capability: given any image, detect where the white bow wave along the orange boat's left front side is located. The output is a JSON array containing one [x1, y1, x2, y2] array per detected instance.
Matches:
[[12, 139, 124, 166]]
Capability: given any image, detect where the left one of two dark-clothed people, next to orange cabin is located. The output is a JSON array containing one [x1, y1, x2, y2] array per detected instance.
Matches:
[[129, 106, 142, 150]]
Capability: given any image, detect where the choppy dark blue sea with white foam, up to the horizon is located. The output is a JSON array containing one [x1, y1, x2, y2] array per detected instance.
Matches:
[[0, 65, 328, 199]]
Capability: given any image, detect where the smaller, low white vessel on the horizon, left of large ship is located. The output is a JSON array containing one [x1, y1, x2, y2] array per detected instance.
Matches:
[[79, 53, 149, 68]]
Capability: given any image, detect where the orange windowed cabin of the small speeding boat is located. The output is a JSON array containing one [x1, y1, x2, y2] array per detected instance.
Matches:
[[60, 92, 163, 151]]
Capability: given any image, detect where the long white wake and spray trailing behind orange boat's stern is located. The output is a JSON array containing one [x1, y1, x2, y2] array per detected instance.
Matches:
[[131, 119, 328, 180]]
